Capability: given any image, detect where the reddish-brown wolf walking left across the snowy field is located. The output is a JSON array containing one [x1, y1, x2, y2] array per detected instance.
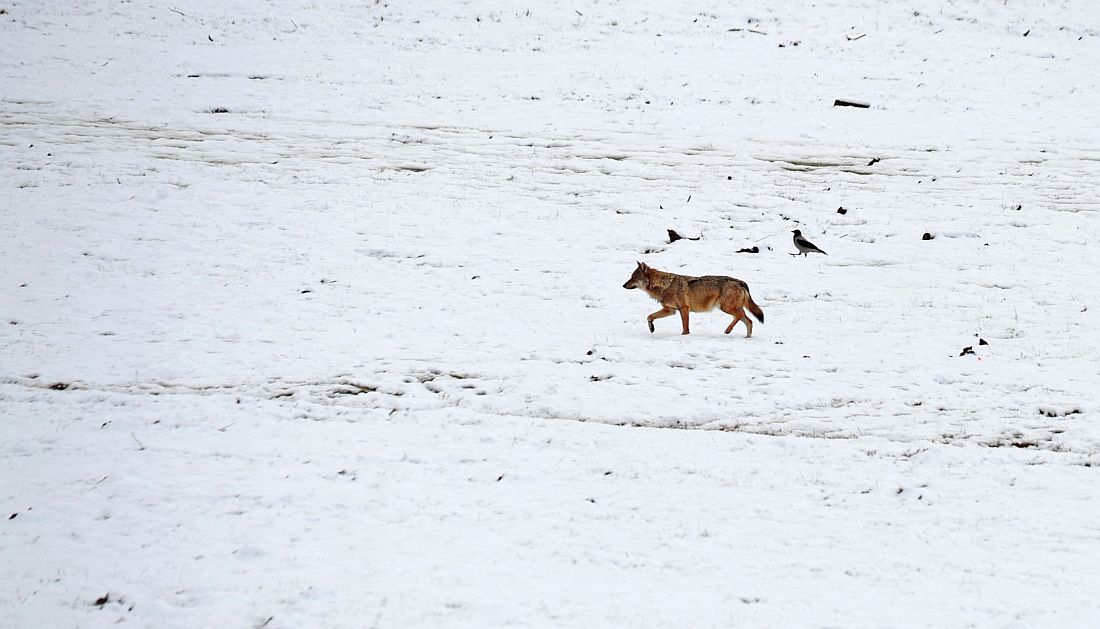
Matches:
[[623, 262, 763, 339]]
